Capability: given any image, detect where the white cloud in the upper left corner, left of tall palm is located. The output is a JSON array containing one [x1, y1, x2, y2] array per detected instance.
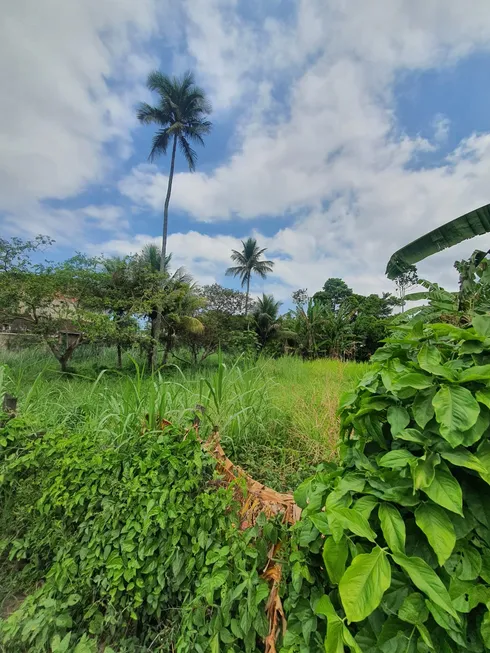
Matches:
[[0, 0, 163, 214]]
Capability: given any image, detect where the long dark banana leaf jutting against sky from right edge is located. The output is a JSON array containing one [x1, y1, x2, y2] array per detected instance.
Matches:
[[386, 204, 490, 279]]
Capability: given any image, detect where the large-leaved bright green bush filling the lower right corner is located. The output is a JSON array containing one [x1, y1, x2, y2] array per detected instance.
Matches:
[[282, 315, 490, 653]]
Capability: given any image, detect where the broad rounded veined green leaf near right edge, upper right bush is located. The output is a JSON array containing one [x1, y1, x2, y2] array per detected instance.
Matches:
[[432, 385, 480, 437]]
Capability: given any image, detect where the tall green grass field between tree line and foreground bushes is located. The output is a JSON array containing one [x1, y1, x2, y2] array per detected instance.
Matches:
[[0, 348, 366, 491]]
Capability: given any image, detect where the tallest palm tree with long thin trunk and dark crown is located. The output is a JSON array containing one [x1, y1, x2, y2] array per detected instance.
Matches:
[[137, 71, 211, 366]]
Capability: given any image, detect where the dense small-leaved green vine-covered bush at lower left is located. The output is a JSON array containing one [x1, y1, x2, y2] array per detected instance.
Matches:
[[0, 417, 278, 653]]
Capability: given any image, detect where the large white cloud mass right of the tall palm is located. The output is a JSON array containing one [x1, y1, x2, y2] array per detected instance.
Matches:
[[119, 0, 490, 292]]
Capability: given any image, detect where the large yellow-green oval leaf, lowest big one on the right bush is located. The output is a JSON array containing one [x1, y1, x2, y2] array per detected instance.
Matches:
[[339, 547, 391, 621]]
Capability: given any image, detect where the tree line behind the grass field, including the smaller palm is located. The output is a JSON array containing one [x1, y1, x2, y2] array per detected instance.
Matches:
[[0, 236, 408, 371]]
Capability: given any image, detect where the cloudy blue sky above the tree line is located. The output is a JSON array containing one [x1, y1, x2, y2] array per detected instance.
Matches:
[[0, 0, 490, 306]]
